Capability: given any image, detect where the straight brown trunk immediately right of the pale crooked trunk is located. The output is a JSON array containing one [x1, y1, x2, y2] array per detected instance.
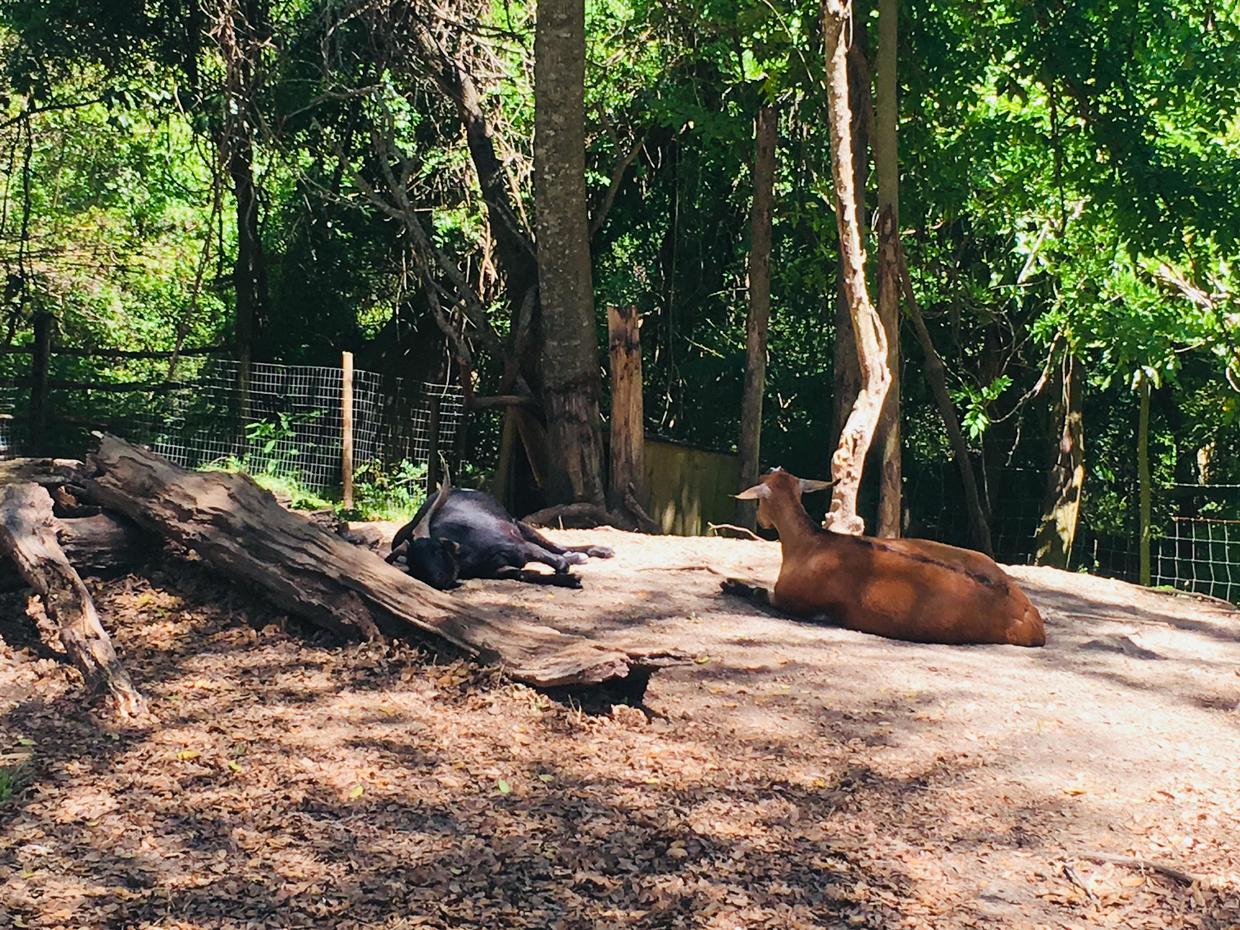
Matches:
[[874, 0, 901, 536]]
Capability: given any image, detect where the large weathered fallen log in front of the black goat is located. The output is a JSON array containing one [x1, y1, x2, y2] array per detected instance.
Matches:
[[81, 435, 684, 691]]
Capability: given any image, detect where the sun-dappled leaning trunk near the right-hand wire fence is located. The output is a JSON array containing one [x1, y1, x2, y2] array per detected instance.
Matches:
[[1034, 348, 1085, 568]]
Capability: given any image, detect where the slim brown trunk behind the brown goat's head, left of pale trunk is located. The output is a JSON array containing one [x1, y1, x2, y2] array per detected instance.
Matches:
[[737, 105, 779, 529]]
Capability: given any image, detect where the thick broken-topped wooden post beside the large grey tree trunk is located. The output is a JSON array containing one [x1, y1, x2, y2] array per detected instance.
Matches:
[[608, 306, 647, 508]]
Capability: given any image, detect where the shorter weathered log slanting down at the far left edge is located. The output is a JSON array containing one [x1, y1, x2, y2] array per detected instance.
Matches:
[[0, 481, 146, 717]]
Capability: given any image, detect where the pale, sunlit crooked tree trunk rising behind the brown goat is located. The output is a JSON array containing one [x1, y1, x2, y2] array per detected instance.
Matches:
[[822, 0, 892, 533]]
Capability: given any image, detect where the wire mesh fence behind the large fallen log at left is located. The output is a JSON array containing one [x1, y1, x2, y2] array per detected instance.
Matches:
[[0, 358, 464, 491]]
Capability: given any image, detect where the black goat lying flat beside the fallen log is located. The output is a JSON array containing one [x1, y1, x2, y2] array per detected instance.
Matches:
[[387, 481, 614, 589]]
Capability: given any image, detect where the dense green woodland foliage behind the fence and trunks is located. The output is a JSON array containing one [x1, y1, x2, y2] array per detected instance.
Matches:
[[0, 0, 1240, 567]]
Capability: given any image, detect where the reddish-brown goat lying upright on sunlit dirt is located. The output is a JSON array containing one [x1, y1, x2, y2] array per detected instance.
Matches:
[[723, 469, 1047, 646]]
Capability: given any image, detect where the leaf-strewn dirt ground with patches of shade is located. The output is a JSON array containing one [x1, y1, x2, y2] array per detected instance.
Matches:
[[0, 531, 1240, 930]]
